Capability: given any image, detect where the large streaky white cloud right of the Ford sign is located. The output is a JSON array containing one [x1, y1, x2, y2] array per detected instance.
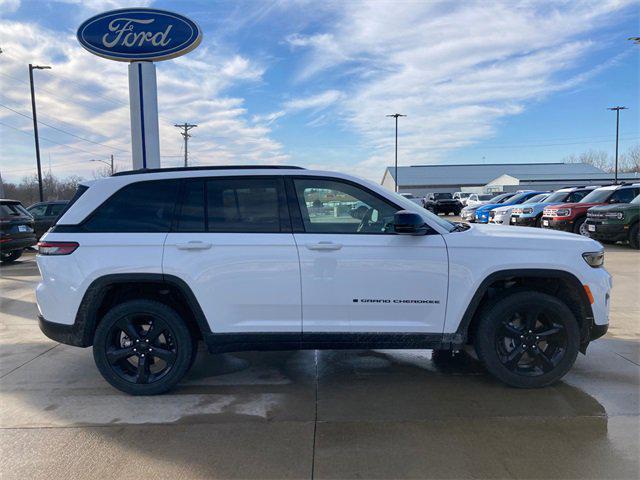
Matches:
[[286, 0, 630, 180]]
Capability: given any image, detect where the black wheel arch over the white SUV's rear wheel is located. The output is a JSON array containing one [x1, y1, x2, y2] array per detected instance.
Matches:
[[74, 273, 211, 347]]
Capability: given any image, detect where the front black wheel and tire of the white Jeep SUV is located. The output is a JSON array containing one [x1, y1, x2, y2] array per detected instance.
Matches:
[[475, 291, 580, 388]]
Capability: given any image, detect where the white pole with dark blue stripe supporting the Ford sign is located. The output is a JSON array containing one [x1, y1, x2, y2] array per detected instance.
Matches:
[[129, 61, 160, 170]]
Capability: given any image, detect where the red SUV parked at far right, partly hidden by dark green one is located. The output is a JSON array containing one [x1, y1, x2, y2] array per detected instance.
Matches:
[[542, 183, 640, 237]]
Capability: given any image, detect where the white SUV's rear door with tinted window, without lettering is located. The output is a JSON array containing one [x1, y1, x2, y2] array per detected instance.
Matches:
[[163, 176, 302, 333]]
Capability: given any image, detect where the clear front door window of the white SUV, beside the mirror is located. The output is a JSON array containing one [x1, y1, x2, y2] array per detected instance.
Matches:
[[294, 178, 398, 233]]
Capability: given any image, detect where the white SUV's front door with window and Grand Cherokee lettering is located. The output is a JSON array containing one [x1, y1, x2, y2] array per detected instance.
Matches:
[[290, 177, 448, 333]]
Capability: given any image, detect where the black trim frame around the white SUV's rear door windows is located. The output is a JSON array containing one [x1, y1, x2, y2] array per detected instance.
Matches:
[[170, 175, 292, 235]]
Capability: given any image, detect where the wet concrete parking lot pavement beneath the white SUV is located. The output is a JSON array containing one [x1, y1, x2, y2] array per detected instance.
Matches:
[[0, 246, 640, 480]]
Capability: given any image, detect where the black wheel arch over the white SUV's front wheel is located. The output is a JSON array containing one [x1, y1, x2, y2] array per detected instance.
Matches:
[[456, 268, 593, 352]]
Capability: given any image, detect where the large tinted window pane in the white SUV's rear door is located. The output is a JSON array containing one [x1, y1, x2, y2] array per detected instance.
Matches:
[[206, 178, 284, 233]]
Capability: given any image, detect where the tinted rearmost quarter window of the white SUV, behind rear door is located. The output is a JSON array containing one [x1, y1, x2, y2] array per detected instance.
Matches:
[[84, 180, 179, 232]]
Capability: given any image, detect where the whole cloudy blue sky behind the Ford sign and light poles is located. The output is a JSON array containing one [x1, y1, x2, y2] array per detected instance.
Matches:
[[0, 0, 640, 181]]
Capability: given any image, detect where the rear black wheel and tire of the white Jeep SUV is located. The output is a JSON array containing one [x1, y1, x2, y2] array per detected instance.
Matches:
[[93, 300, 196, 395]]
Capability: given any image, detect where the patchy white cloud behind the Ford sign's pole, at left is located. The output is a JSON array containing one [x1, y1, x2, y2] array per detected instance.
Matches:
[[0, 21, 287, 180]]
